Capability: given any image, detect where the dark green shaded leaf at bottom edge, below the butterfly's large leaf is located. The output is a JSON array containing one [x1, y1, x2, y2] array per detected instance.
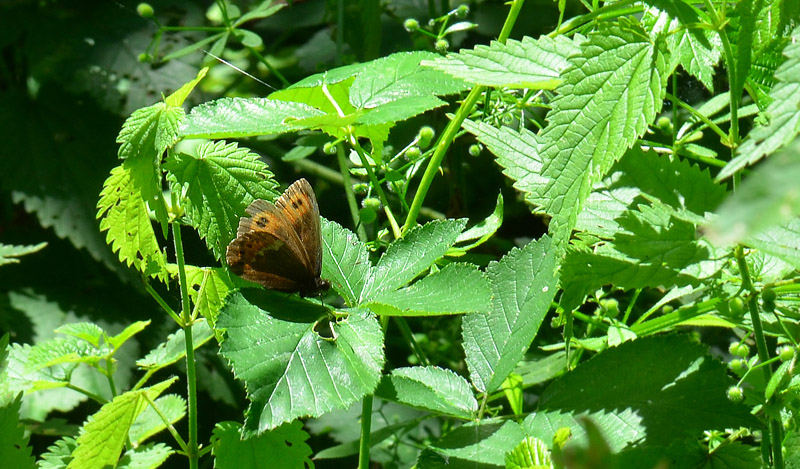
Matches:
[[211, 421, 314, 469]]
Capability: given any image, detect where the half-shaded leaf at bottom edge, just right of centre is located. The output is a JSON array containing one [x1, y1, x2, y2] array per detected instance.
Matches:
[[431, 419, 527, 467]]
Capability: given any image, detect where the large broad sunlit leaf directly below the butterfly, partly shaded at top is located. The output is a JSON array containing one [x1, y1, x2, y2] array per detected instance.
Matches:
[[217, 290, 384, 435]]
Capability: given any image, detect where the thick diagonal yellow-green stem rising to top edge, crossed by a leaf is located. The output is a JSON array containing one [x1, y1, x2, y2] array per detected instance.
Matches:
[[402, 0, 525, 235]]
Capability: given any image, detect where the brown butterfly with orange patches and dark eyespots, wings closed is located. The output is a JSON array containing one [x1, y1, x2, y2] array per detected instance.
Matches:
[[226, 179, 330, 296]]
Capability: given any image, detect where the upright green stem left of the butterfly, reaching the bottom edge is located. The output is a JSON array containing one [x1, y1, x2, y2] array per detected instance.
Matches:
[[172, 222, 198, 469]]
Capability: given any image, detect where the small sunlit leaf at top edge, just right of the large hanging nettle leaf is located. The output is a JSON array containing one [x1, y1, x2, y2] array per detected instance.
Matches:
[[644, 0, 722, 91]]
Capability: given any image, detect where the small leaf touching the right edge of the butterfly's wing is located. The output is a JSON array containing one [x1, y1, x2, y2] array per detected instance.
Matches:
[[321, 218, 371, 306]]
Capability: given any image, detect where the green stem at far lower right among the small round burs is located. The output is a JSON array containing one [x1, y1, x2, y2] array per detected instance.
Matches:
[[734, 245, 783, 468]]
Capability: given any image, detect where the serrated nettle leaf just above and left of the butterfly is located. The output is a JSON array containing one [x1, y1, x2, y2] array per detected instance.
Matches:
[[164, 141, 280, 259]]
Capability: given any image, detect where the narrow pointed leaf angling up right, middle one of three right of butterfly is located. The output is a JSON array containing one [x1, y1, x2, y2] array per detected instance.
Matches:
[[361, 220, 467, 302]]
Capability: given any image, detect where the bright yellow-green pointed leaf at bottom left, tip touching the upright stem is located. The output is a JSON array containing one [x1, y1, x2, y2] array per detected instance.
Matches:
[[67, 378, 178, 469]]
